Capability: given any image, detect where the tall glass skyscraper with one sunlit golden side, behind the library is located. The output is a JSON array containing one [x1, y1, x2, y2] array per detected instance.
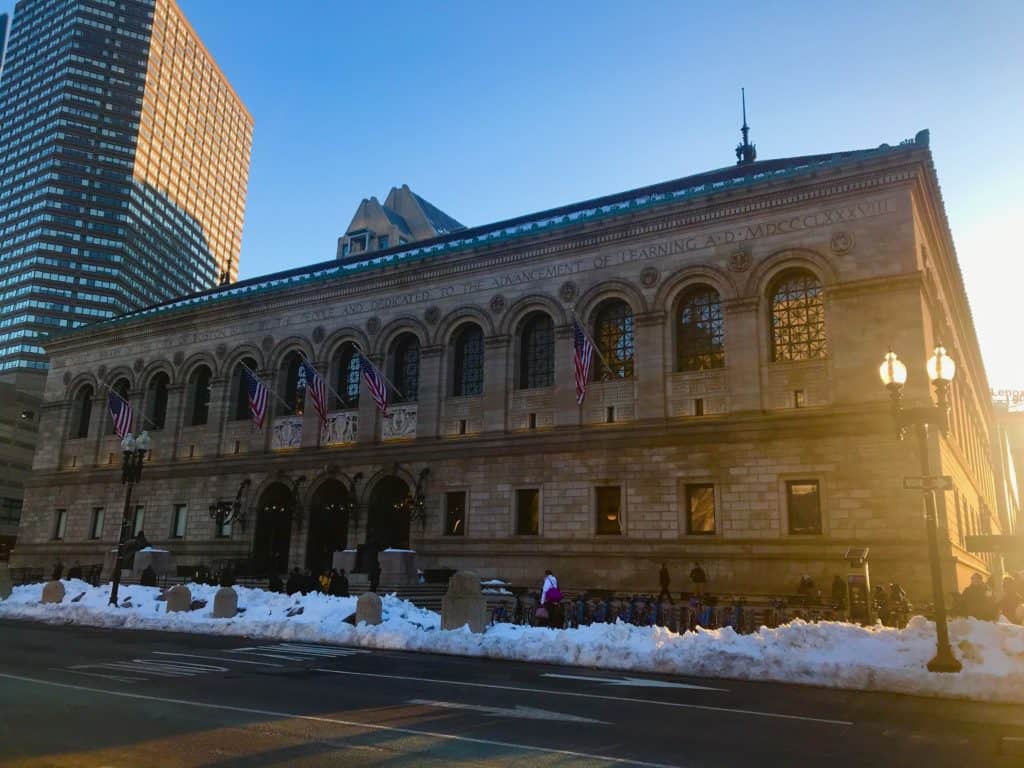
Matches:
[[0, 0, 253, 376]]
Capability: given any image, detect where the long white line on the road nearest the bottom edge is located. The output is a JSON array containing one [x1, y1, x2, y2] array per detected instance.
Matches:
[[0, 672, 681, 768]]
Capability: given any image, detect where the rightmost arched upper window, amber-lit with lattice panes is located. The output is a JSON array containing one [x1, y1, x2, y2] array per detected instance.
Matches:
[[771, 269, 826, 361]]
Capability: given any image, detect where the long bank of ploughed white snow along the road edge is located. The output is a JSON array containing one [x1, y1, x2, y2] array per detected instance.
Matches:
[[0, 580, 1024, 702]]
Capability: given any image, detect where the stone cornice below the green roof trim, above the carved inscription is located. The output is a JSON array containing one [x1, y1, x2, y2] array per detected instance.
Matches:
[[48, 158, 921, 355]]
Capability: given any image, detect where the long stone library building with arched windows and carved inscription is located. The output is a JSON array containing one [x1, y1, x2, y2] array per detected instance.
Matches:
[[11, 131, 1018, 599]]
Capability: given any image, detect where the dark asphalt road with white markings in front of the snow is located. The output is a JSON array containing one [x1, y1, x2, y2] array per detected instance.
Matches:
[[0, 622, 1024, 768]]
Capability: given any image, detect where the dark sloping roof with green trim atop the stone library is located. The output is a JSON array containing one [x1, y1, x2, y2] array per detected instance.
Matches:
[[77, 130, 929, 336]]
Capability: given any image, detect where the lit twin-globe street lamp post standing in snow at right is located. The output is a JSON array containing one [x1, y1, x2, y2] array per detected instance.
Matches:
[[879, 344, 962, 672]]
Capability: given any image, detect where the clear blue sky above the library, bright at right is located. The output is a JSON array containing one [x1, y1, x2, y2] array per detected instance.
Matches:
[[0, 0, 1024, 389]]
